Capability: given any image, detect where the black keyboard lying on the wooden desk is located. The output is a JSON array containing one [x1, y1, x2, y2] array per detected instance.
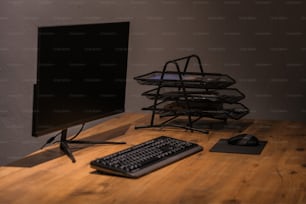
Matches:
[[90, 136, 203, 178]]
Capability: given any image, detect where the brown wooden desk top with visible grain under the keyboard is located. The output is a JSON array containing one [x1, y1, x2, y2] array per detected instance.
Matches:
[[0, 114, 306, 204]]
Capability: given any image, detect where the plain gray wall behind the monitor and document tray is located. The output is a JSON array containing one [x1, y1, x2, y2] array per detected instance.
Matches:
[[0, 0, 306, 164]]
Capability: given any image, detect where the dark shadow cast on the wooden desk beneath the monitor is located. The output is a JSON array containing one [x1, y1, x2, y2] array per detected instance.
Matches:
[[6, 125, 130, 167]]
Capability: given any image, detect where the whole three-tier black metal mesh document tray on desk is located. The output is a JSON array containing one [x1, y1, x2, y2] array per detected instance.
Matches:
[[134, 55, 249, 133]]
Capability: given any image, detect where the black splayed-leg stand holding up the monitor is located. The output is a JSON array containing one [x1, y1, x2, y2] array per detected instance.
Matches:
[[60, 129, 126, 163]]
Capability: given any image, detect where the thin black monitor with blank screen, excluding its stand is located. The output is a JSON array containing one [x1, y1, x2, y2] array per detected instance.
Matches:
[[32, 22, 129, 137]]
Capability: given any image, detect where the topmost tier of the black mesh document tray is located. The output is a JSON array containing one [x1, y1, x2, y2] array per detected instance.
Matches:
[[134, 71, 235, 89]]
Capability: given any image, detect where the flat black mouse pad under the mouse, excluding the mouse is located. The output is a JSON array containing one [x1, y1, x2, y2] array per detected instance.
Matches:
[[210, 139, 267, 154]]
